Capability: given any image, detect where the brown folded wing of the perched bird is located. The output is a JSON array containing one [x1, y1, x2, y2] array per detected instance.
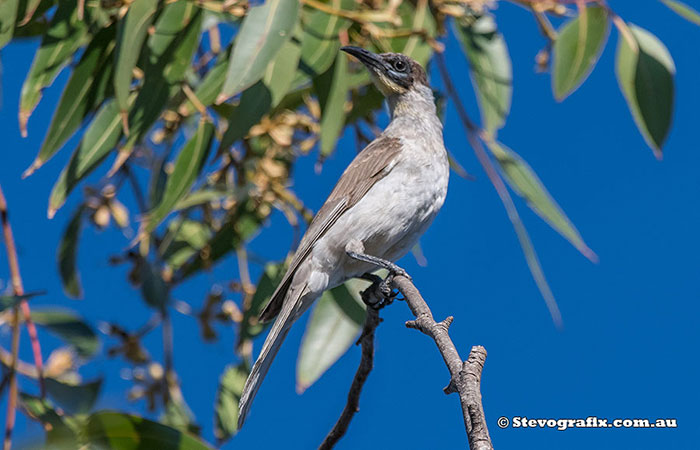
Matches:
[[260, 136, 401, 322]]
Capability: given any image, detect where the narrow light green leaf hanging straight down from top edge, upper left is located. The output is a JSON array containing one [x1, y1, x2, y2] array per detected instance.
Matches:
[[114, 0, 158, 123]]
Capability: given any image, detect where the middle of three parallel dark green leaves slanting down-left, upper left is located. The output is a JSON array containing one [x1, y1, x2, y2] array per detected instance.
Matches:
[[22, 27, 115, 177]]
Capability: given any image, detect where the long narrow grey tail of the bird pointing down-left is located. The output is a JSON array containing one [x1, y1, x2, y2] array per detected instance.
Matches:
[[238, 285, 306, 429]]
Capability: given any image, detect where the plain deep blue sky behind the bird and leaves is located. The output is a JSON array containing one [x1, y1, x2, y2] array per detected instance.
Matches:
[[0, 1, 700, 449]]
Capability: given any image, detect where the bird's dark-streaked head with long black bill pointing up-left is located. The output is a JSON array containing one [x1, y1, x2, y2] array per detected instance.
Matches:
[[341, 46, 428, 98]]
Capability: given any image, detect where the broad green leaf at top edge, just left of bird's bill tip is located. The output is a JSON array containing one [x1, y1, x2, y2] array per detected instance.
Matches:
[[293, 0, 354, 82]]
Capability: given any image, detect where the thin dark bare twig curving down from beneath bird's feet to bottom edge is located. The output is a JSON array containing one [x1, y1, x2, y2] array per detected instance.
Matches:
[[318, 307, 381, 450]]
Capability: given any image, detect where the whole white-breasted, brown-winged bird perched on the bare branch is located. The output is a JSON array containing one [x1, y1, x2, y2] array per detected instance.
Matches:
[[238, 46, 449, 429]]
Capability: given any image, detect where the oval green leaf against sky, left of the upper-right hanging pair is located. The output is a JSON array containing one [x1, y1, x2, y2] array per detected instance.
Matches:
[[552, 6, 610, 101]]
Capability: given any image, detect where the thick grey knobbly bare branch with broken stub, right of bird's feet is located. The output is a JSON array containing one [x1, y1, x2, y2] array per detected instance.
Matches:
[[393, 275, 493, 450]]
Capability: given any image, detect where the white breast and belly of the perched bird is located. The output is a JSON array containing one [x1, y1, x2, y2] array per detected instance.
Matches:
[[311, 112, 449, 288]]
